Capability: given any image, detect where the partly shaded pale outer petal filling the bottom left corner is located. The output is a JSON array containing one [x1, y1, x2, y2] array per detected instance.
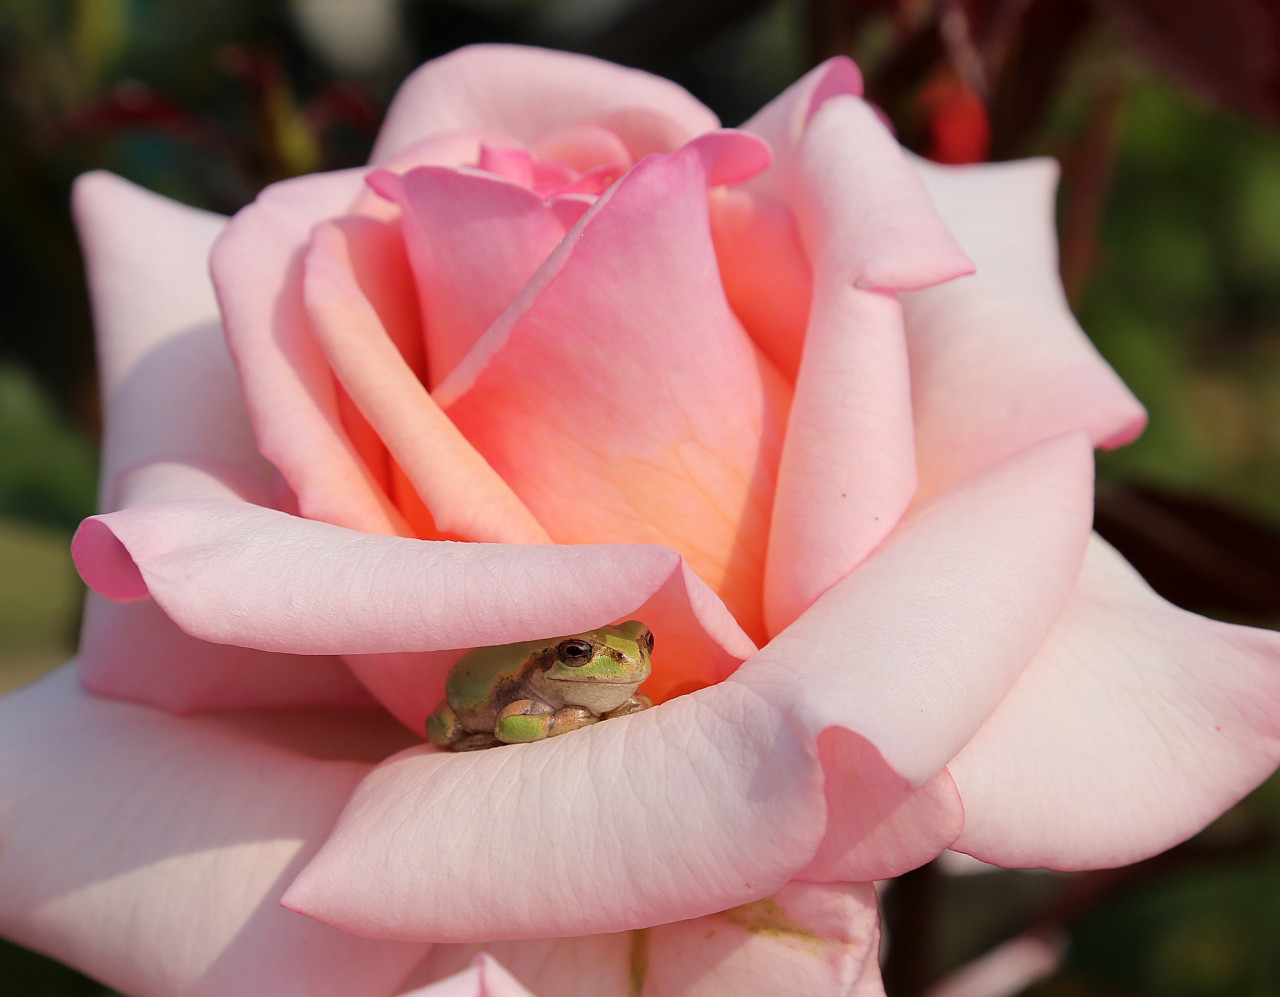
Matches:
[[0, 668, 424, 997]]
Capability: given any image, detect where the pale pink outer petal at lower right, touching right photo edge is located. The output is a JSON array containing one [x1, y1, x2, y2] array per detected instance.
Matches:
[[951, 540, 1280, 869]]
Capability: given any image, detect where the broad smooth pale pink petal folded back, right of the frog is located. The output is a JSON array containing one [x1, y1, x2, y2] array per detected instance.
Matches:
[[730, 434, 1093, 872]]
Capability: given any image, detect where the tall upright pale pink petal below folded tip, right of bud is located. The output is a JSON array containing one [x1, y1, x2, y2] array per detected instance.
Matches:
[[764, 284, 915, 634]]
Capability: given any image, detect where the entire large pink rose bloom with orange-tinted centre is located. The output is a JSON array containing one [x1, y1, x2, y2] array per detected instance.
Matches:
[[0, 47, 1280, 997]]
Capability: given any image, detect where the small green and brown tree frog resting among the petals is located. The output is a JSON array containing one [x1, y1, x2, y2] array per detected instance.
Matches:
[[426, 619, 653, 751]]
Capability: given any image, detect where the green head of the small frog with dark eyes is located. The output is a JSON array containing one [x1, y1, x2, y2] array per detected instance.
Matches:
[[536, 619, 653, 713]]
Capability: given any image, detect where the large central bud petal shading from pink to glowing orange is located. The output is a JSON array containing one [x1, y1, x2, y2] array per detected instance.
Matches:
[[435, 132, 790, 635]]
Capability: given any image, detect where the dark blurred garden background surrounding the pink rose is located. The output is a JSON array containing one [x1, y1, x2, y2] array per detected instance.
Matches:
[[0, 0, 1280, 997]]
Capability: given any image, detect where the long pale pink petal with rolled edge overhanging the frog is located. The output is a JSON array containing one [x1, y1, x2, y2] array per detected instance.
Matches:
[[72, 496, 755, 730]]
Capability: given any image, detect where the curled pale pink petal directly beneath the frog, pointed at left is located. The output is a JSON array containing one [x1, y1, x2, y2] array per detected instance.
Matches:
[[284, 682, 826, 942]]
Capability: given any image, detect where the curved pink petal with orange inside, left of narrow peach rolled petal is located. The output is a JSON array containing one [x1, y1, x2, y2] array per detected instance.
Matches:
[[212, 132, 501, 535]]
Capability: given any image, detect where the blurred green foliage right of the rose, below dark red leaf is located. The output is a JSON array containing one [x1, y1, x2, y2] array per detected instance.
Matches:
[[1079, 78, 1280, 522]]
